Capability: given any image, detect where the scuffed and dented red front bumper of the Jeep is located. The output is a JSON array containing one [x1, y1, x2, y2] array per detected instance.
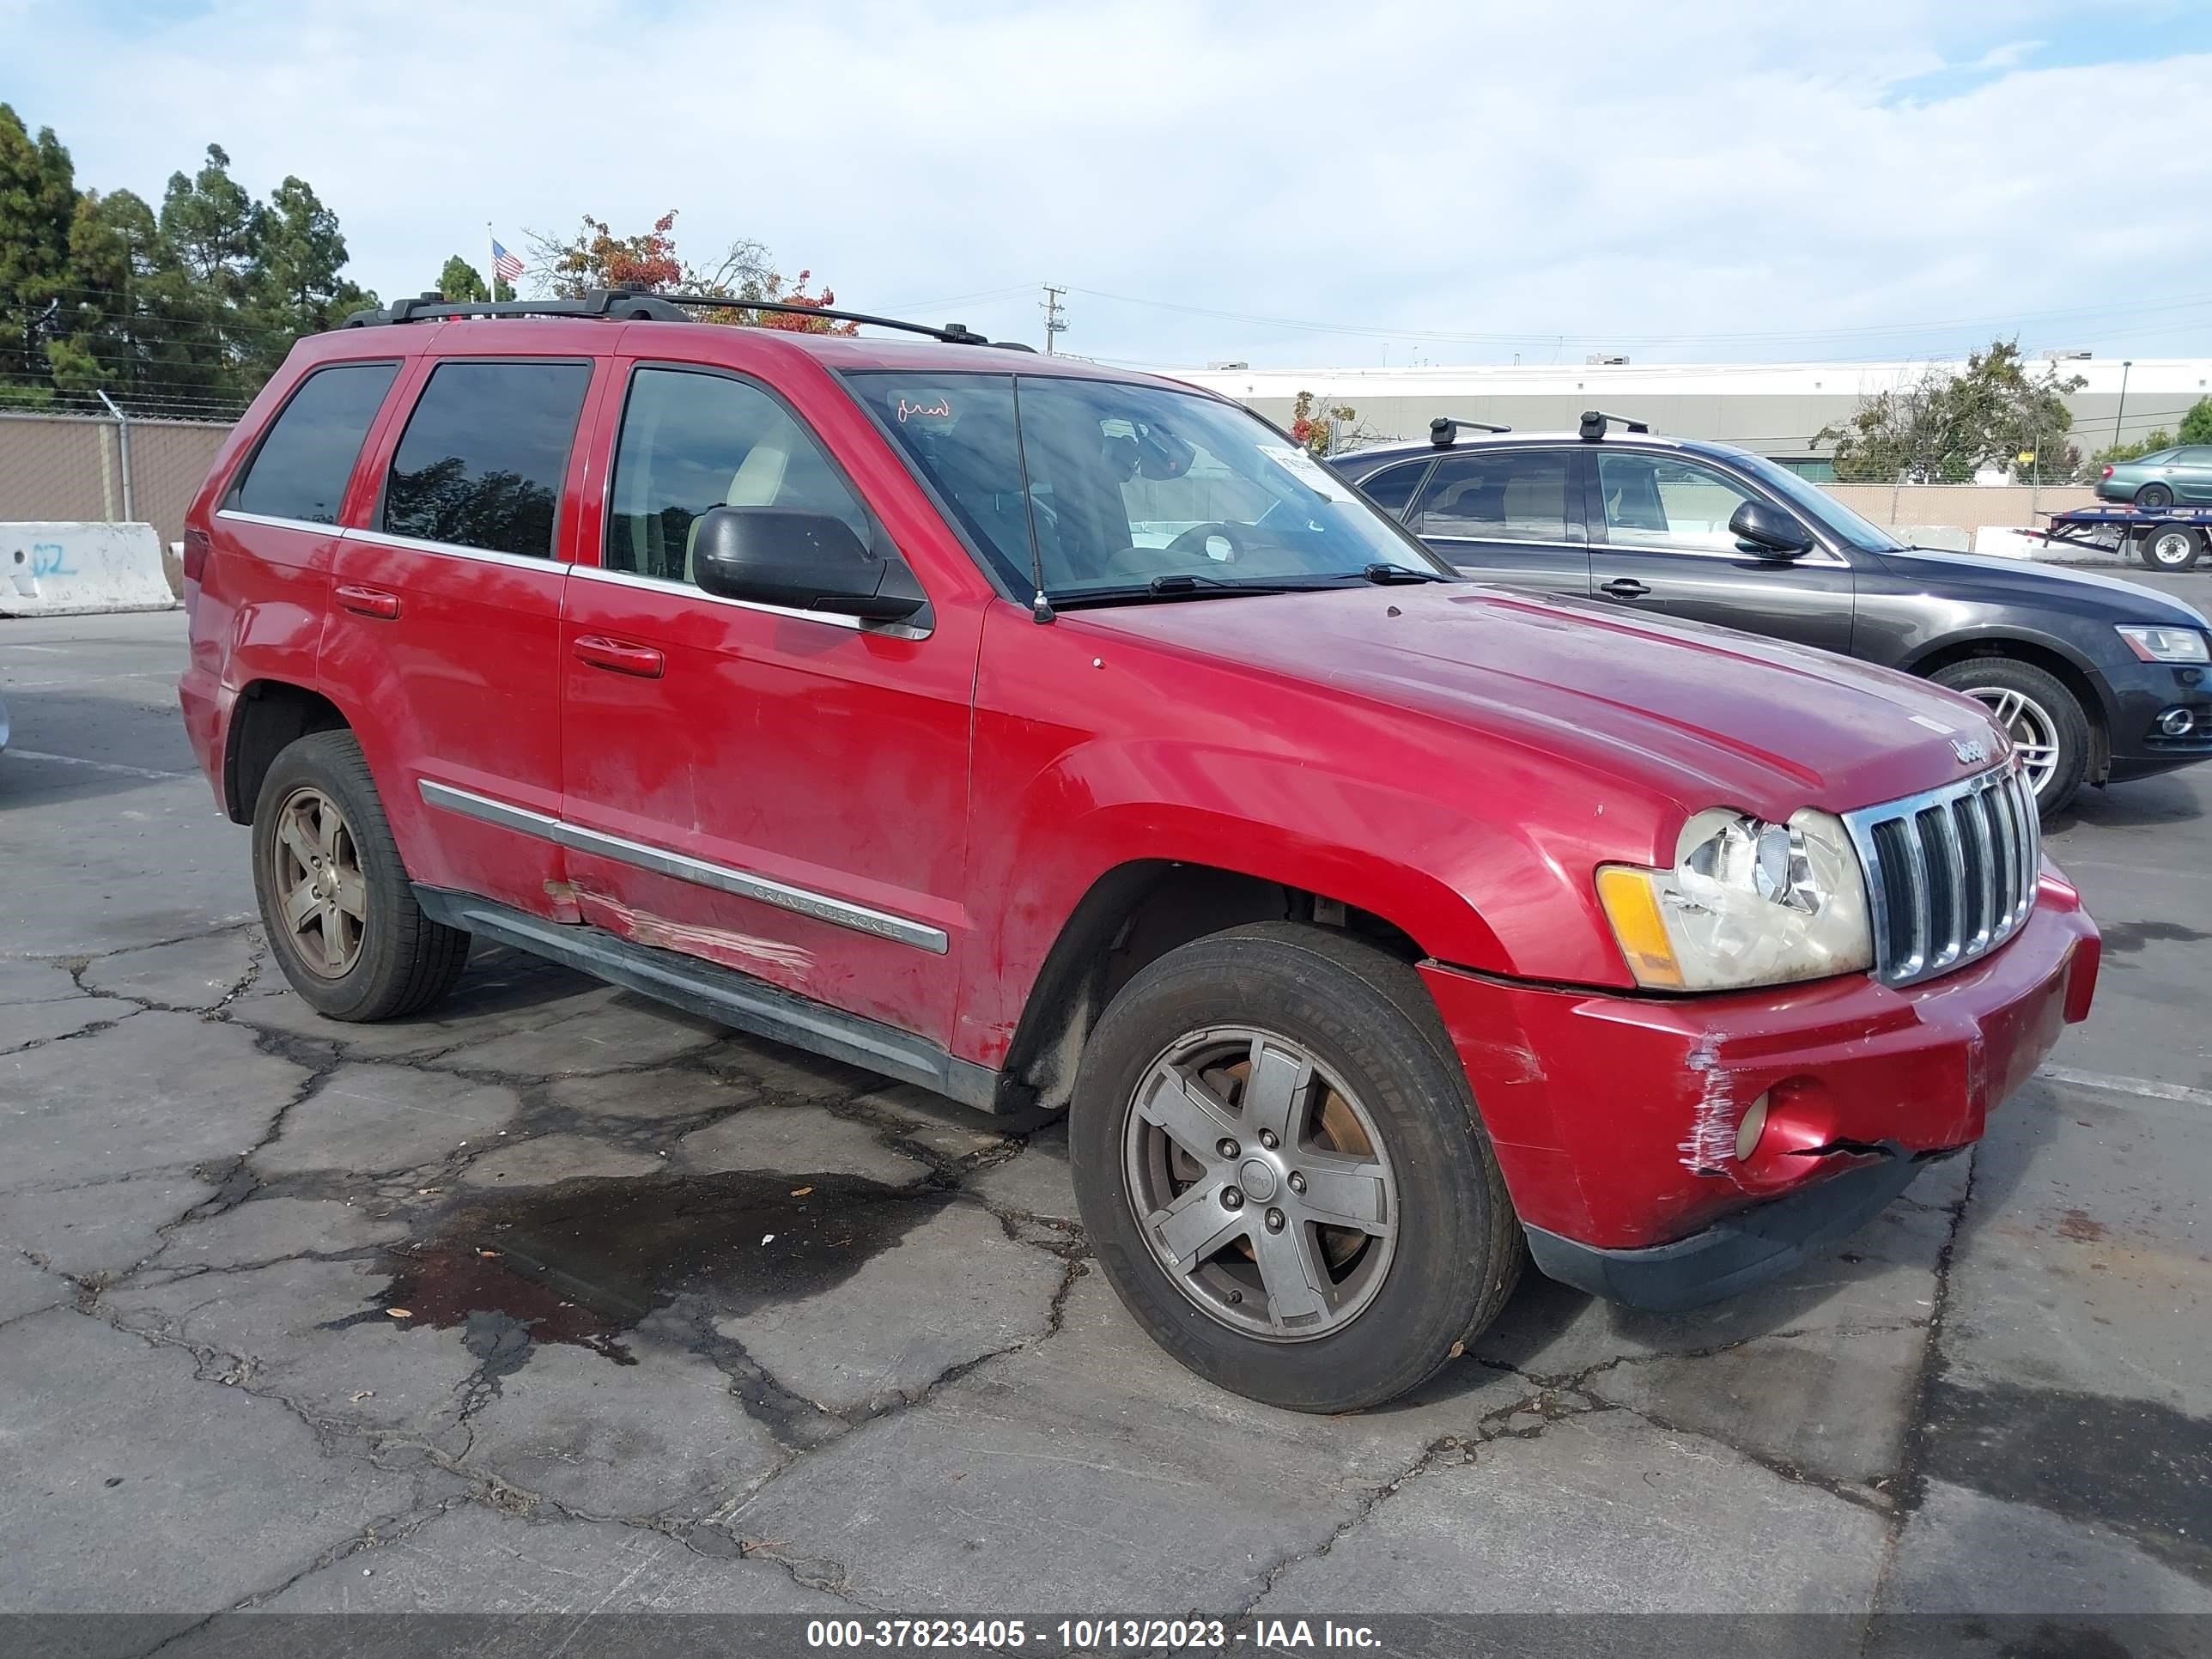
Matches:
[[1422, 863, 2100, 1265]]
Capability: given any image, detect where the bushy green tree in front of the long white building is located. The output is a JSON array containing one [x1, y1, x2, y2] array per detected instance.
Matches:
[[1820, 341, 2086, 484]]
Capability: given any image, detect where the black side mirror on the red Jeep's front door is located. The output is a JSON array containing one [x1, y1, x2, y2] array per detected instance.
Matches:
[[692, 507, 927, 622]]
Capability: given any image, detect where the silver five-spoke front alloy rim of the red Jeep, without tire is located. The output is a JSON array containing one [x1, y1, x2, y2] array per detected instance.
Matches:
[[1124, 1026, 1398, 1343]]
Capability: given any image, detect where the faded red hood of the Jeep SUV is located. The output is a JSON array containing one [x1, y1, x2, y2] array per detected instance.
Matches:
[[1068, 584, 2008, 818]]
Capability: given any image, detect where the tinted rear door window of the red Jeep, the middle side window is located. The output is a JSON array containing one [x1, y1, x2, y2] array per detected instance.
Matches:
[[383, 362, 591, 560]]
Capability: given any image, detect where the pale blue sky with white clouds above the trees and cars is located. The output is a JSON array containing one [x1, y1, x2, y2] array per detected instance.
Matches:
[[0, 0, 2212, 368]]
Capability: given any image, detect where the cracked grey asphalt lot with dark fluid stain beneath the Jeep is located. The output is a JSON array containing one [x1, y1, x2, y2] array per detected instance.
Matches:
[[0, 601, 2212, 1650]]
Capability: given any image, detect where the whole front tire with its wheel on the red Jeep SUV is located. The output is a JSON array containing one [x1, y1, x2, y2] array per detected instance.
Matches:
[[1068, 922, 1526, 1411]]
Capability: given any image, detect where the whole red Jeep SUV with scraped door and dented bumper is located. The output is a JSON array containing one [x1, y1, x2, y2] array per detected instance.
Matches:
[[181, 292, 2100, 1411]]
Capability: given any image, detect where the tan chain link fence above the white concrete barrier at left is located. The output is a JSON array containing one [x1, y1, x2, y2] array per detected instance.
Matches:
[[0, 400, 232, 546]]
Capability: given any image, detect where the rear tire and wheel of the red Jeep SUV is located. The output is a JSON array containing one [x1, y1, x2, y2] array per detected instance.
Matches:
[[254, 732, 469, 1022]]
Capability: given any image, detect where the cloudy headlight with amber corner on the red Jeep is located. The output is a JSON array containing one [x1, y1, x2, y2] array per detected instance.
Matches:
[[1597, 807, 1874, 991]]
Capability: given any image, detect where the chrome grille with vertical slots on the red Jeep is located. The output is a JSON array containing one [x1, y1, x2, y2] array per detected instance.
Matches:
[[1843, 765, 2042, 984]]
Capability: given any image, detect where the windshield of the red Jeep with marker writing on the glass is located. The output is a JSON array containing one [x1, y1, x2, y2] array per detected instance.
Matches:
[[845, 369, 1451, 604]]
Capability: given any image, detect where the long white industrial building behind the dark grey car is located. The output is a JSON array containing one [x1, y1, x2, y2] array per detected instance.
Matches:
[[1170, 356, 2212, 480]]
